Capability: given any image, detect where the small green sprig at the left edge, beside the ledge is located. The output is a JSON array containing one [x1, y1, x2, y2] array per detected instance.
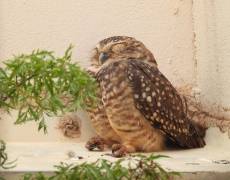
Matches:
[[0, 140, 16, 169]]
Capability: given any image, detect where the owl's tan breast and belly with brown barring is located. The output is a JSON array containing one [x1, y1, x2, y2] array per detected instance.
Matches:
[[95, 61, 163, 151]]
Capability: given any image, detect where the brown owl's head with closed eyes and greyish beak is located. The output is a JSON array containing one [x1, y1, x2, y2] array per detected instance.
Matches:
[[91, 36, 157, 71]]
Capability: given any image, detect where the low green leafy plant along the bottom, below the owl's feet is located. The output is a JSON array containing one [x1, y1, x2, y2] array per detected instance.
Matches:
[[22, 154, 180, 180]]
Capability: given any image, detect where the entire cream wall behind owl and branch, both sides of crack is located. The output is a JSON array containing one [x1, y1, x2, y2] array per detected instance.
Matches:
[[0, 0, 230, 141]]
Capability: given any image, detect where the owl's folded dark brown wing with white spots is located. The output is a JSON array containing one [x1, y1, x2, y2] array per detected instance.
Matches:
[[127, 60, 205, 148]]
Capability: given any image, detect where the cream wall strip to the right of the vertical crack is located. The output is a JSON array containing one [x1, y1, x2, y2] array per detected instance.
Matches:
[[193, 0, 230, 117]]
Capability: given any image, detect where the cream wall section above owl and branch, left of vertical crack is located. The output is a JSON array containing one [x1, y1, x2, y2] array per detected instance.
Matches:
[[0, 0, 194, 82]]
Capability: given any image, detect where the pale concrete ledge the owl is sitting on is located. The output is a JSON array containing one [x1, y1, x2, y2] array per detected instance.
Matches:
[[1, 129, 230, 180]]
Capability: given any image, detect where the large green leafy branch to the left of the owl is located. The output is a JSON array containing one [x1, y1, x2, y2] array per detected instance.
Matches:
[[0, 46, 96, 132]]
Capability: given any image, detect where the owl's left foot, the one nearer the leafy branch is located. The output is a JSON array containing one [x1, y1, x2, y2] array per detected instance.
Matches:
[[85, 136, 106, 151]]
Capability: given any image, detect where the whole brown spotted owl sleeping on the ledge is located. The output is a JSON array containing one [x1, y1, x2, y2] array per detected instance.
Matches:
[[86, 36, 205, 157]]
